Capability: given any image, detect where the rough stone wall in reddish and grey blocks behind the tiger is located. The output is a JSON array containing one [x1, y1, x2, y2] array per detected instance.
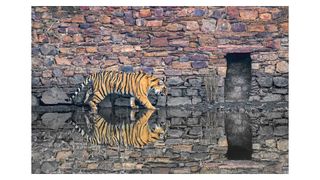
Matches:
[[32, 7, 288, 106]]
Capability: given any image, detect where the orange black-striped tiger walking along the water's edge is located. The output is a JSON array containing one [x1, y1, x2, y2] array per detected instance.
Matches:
[[69, 71, 167, 112]]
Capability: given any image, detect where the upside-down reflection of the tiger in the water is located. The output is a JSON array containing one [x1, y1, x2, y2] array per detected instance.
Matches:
[[71, 110, 165, 148]]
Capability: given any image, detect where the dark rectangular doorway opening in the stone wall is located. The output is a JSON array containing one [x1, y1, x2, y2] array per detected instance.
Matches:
[[224, 53, 251, 102]]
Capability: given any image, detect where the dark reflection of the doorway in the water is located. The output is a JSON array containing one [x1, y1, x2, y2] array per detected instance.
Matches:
[[225, 112, 252, 160]]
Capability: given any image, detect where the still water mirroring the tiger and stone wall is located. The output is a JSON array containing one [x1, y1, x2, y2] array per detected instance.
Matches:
[[32, 104, 288, 173]]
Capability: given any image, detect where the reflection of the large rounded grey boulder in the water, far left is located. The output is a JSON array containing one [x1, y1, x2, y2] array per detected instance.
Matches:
[[41, 113, 72, 129]]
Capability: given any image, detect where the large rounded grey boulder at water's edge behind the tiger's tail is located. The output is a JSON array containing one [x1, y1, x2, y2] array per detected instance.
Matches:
[[41, 87, 71, 104]]
